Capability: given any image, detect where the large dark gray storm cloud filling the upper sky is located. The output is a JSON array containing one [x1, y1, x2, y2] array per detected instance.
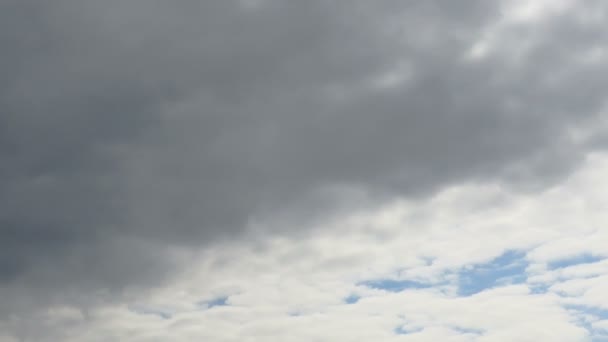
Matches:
[[0, 0, 607, 313]]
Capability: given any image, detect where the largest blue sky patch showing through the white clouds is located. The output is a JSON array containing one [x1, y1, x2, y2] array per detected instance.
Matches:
[[458, 250, 528, 296]]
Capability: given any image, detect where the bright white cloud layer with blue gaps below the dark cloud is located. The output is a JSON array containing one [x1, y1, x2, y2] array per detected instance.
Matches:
[[3, 155, 608, 341]]
